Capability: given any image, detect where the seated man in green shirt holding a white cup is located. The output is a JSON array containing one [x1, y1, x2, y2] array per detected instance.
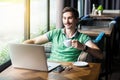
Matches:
[[24, 7, 103, 62]]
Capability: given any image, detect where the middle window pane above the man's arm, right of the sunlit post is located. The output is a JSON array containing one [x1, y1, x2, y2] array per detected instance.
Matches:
[[30, 0, 47, 38]]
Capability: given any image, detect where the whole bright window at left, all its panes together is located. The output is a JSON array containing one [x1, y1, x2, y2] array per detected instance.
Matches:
[[0, 0, 56, 69]]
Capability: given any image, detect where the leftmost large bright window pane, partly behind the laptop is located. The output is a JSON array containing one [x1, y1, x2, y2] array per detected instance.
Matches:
[[0, 0, 24, 65]]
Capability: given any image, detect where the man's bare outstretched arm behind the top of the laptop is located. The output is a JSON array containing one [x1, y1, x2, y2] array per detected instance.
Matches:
[[23, 34, 49, 44]]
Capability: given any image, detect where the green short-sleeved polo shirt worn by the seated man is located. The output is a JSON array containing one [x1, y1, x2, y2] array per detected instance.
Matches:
[[46, 29, 90, 62]]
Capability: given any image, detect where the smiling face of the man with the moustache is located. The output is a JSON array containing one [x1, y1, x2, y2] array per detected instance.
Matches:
[[62, 12, 78, 29]]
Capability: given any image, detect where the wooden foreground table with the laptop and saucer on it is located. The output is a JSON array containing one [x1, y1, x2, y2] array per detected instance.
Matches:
[[0, 62, 101, 80]]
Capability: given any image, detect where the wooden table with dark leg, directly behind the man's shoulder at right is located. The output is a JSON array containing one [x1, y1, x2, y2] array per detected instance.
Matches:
[[79, 26, 114, 80]]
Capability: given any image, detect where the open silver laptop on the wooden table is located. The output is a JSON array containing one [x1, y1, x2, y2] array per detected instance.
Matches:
[[9, 43, 60, 71]]
